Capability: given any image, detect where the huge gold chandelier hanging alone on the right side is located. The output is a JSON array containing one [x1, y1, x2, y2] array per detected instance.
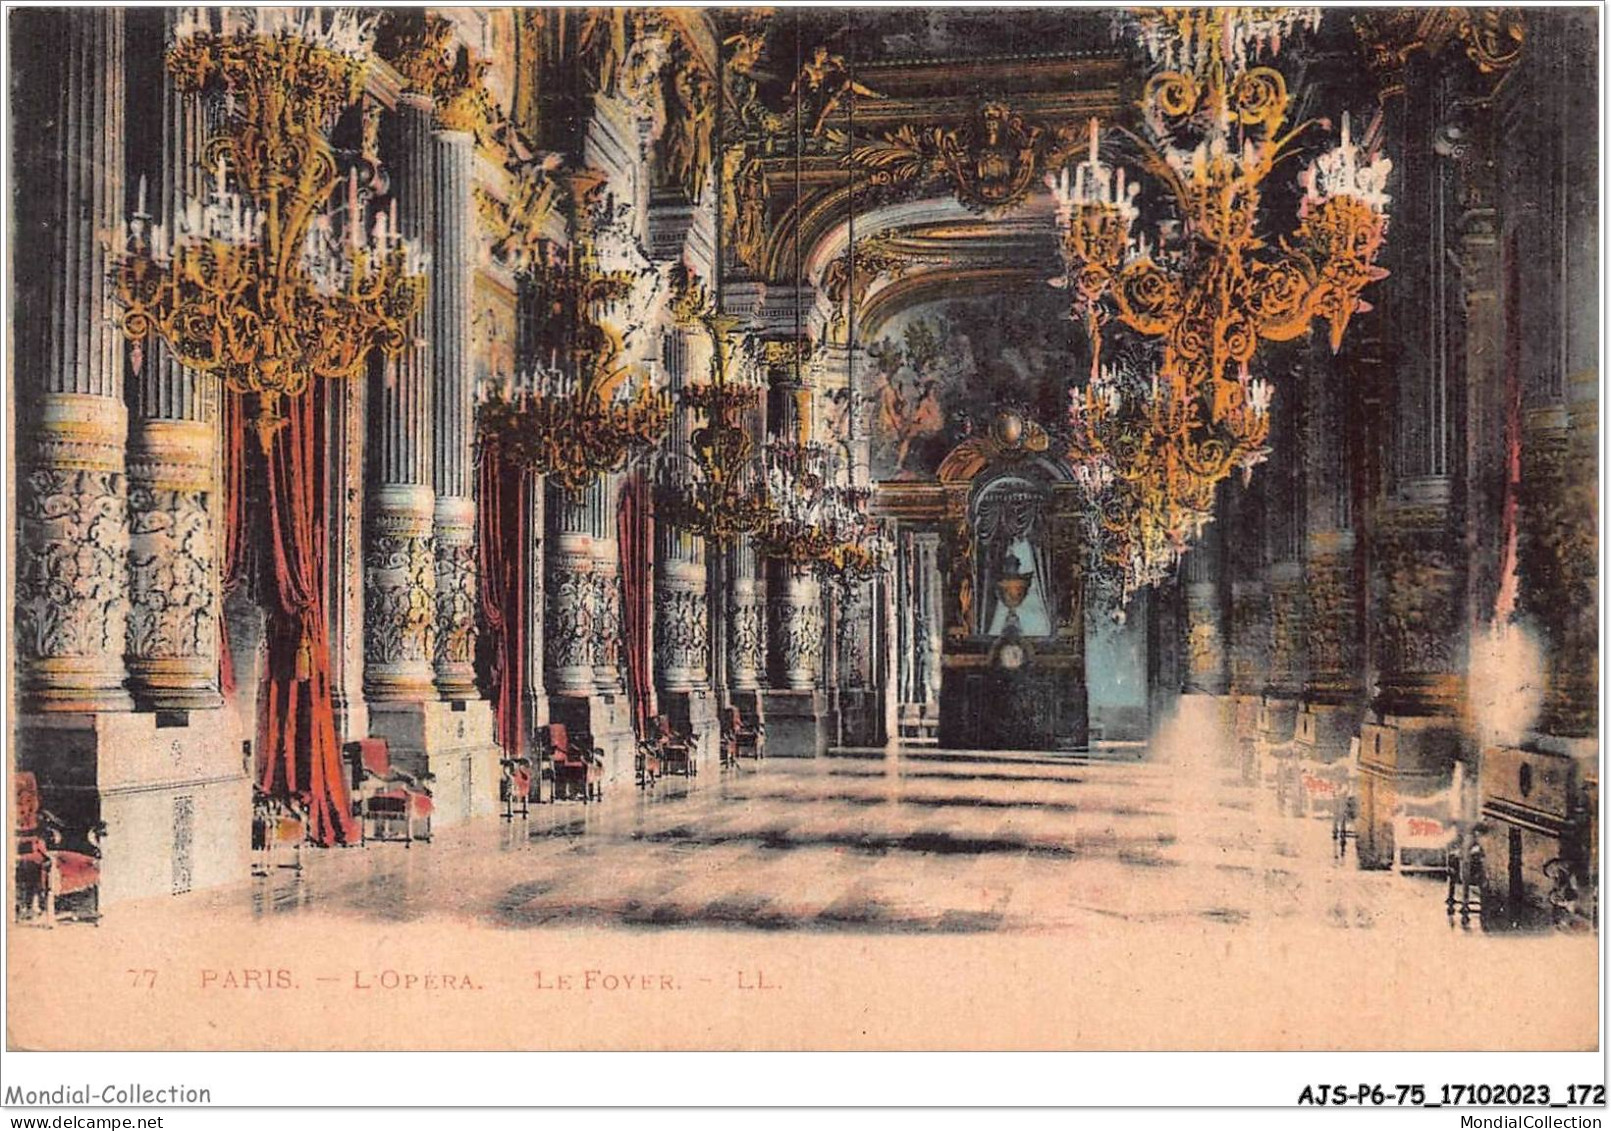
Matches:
[[1049, 8, 1392, 599]]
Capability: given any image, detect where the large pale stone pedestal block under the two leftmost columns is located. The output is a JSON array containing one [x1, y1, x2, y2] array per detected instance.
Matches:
[[16, 711, 251, 909]]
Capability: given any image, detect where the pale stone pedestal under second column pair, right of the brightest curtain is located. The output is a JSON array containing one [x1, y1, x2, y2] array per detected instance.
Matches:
[[369, 699, 503, 830]]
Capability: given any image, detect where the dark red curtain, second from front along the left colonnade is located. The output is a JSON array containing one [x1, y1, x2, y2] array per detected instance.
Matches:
[[475, 445, 530, 757]]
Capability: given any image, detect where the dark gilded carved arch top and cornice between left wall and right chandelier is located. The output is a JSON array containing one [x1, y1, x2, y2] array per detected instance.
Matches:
[[723, 8, 1134, 330]]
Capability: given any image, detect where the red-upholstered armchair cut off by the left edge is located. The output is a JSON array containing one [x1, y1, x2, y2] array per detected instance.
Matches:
[[16, 773, 106, 926]]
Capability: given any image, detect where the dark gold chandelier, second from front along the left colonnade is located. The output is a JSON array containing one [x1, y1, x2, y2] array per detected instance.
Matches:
[[477, 169, 672, 493]]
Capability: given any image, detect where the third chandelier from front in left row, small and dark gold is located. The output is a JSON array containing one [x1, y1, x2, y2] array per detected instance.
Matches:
[[659, 308, 775, 545]]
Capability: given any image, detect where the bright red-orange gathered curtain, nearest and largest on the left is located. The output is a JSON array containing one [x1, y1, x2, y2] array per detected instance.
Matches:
[[254, 382, 358, 844]]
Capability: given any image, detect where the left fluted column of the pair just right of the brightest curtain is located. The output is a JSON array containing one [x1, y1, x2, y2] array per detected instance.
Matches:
[[364, 93, 437, 701]]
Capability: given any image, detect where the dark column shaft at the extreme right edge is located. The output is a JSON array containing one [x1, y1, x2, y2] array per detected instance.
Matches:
[[1500, 11, 1600, 751]]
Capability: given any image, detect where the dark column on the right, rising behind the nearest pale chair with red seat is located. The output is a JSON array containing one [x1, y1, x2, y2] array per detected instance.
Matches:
[[1358, 68, 1475, 867]]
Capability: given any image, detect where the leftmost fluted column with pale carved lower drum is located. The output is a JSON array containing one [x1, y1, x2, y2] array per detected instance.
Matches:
[[11, 8, 132, 712]]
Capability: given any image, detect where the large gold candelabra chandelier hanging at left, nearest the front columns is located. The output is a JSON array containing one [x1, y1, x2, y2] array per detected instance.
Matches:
[[113, 8, 425, 446]]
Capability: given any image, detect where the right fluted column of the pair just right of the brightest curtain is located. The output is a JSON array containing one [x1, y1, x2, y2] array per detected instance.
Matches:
[[430, 131, 480, 699]]
